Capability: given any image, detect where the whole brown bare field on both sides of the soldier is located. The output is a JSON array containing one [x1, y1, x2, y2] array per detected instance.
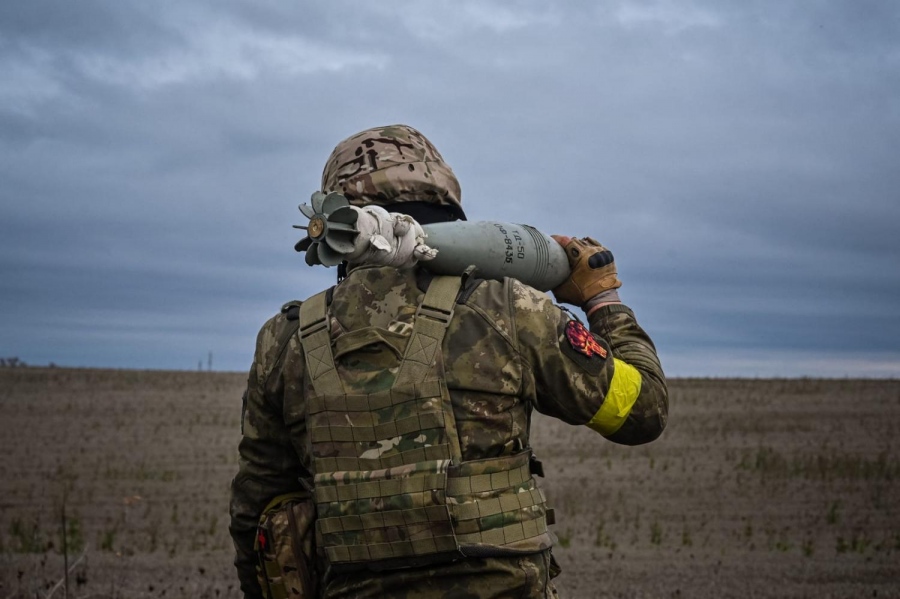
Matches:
[[0, 368, 900, 599]]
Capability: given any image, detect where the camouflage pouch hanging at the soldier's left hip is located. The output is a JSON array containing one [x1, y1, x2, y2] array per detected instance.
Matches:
[[254, 491, 316, 599]]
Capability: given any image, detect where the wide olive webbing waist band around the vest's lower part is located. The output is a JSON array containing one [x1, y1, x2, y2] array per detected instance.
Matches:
[[315, 451, 550, 563]]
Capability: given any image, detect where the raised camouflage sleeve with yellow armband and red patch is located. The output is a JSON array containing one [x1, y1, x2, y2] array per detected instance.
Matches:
[[510, 280, 668, 445]]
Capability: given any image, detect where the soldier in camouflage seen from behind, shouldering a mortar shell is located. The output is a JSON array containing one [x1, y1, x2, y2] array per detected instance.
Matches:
[[230, 125, 668, 599]]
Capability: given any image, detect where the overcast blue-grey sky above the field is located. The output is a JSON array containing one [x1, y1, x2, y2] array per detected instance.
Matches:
[[0, 0, 900, 377]]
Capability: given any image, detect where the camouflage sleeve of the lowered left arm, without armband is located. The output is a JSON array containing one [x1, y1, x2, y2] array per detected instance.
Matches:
[[229, 315, 301, 597]]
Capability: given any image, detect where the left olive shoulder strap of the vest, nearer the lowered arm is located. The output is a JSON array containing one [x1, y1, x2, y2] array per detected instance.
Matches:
[[300, 291, 344, 395]]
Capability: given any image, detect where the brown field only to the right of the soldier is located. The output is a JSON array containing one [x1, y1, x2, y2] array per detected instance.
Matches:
[[534, 380, 900, 597]]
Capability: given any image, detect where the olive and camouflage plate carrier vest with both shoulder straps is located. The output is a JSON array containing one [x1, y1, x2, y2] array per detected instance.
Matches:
[[299, 277, 553, 570]]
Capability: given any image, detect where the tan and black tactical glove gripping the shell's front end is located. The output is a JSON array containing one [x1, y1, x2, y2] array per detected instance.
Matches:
[[553, 235, 622, 308]]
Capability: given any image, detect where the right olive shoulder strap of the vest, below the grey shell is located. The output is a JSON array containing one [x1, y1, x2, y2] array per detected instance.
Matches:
[[394, 277, 461, 387]]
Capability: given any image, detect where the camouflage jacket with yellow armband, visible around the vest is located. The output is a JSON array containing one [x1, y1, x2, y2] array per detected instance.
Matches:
[[231, 267, 668, 598]]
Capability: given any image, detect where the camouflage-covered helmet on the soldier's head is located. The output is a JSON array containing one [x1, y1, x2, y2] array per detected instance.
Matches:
[[322, 125, 465, 218]]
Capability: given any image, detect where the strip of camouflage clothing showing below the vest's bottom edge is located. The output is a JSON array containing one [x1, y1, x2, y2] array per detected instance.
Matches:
[[323, 551, 559, 599]]
